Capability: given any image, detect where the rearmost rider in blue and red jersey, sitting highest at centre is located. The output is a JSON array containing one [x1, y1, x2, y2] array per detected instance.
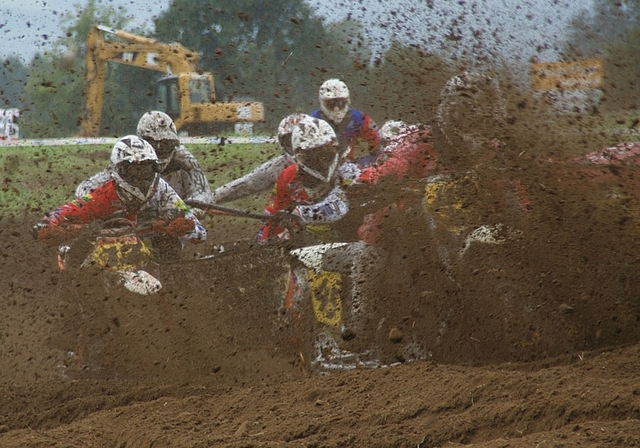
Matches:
[[310, 79, 380, 167]]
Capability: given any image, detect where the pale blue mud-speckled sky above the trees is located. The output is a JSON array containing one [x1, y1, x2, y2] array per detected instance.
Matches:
[[0, 0, 593, 70]]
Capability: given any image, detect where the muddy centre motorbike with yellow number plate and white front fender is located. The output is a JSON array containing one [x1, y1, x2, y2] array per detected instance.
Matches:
[[185, 198, 390, 372]]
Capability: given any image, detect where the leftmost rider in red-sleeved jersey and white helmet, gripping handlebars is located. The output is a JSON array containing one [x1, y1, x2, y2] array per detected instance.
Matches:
[[32, 135, 207, 260]]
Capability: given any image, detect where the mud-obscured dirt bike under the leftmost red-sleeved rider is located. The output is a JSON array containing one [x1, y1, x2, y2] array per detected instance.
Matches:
[[49, 219, 220, 378]]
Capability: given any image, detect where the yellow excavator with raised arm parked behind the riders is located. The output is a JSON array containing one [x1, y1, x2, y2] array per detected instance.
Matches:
[[82, 25, 264, 137]]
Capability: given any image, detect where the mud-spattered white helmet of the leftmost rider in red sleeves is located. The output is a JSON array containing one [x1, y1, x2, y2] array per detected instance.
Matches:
[[111, 135, 158, 201]]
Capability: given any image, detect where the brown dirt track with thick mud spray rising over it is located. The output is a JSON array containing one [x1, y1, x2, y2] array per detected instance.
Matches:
[[0, 128, 640, 447]]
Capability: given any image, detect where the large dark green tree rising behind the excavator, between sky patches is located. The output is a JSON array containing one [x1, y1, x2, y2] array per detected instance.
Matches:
[[155, 0, 352, 129]]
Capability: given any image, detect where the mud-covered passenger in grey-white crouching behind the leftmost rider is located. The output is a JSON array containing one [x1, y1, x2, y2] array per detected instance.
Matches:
[[76, 110, 213, 203]]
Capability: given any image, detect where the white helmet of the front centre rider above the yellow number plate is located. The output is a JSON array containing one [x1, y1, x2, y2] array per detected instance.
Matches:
[[291, 117, 340, 182]]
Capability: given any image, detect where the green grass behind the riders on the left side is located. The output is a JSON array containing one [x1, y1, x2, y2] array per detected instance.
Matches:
[[0, 144, 279, 218]]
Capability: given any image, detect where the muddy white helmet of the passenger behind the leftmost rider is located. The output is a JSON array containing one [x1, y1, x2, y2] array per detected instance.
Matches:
[[137, 110, 180, 169]]
